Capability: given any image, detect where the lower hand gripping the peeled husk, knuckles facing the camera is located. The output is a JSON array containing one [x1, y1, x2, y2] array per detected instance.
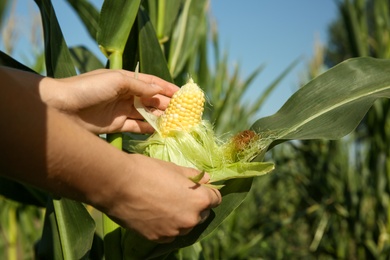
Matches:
[[103, 154, 221, 243]]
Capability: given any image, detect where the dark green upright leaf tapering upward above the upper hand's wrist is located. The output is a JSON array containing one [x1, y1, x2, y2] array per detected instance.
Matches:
[[35, 0, 76, 78]]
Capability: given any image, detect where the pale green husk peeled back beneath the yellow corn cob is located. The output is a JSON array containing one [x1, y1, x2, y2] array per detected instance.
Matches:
[[125, 120, 274, 188]]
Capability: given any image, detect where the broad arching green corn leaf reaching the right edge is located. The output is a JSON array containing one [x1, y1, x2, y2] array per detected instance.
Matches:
[[252, 58, 390, 149]]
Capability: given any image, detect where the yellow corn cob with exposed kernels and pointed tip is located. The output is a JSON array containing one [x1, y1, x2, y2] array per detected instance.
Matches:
[[157, 78, 205, 136]]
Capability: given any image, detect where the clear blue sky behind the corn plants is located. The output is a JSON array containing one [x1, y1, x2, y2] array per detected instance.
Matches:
[[6, 0, 338, 116]]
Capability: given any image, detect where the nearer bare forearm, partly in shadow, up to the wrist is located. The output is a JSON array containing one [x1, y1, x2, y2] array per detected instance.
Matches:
[[0, 67, 129, 209]]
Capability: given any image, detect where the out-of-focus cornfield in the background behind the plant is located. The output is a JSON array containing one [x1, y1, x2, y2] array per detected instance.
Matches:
[[0, 0, 390, 259]]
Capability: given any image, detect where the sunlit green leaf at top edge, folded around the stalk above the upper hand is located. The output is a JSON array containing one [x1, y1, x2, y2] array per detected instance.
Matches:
[[97, 0, 141, 57]]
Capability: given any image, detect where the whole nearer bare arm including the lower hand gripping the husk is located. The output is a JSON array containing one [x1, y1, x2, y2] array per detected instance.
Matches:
[[0, 68, 221, 240]]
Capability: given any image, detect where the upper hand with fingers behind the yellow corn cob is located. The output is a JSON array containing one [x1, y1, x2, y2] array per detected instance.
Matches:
[[39, 69, 179, 134]]
